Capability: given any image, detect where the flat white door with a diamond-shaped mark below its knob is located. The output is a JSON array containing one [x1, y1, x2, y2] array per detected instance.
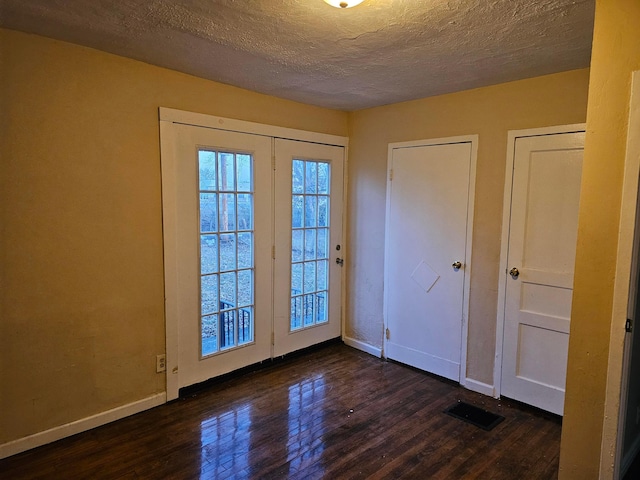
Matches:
[[385, 141, 474, 381]]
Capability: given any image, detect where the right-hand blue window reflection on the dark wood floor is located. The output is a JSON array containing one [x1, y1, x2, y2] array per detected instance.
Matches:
[[287, 375, 326, 474]]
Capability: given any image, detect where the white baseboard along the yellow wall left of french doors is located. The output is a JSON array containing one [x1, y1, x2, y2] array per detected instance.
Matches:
[[0, 392, 167, 459]]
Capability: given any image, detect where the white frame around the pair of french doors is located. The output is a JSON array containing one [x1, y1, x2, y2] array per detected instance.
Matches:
[[159, 107, 349, 401]]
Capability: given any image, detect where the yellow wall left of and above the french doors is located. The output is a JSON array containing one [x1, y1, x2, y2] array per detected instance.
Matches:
[[0, 30, 348, 444]]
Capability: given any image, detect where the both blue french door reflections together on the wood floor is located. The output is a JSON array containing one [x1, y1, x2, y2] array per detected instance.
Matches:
[[195, 375, 328, 480]]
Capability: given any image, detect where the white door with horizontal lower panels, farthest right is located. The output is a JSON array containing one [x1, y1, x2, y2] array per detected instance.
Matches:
[[501, 132, 584, 415]]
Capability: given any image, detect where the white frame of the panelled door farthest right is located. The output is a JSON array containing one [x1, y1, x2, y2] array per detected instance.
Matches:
[[493, 123, 585, 398]]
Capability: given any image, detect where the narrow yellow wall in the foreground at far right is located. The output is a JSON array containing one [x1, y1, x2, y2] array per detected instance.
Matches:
[[560, 0, 640, 479]]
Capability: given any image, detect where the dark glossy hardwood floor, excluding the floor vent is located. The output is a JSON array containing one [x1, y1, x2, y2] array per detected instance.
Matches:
[[0, 344, 561, 480]]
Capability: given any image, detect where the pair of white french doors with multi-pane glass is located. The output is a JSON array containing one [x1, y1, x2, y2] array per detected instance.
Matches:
[[161, 111, 344, 399]]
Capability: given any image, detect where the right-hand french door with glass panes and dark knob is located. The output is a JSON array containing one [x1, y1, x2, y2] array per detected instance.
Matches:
[[274, 139, 344, 356]]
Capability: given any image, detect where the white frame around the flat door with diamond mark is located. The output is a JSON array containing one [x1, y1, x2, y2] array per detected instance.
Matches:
[[382, 135, 478, 386]]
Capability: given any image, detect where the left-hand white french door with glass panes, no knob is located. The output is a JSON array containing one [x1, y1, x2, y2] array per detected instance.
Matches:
[[163, 124, 273, 388]]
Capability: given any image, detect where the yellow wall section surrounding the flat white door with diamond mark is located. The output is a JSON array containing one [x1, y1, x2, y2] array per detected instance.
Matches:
[[347, 70, 588, 385]]
